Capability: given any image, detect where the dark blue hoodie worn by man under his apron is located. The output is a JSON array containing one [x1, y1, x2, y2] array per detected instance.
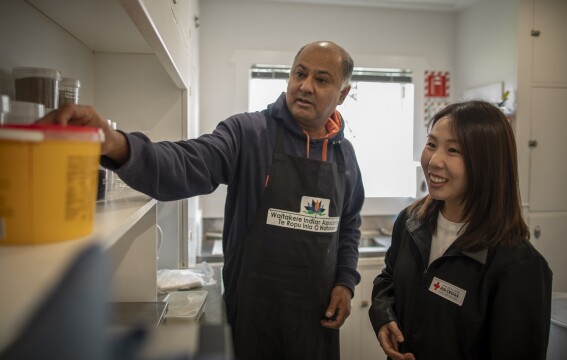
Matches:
[[102, 93, 364, 294]]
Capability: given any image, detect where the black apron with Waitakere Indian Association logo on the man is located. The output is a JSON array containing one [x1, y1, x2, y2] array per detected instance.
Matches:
[[226, 123, 345, 360]]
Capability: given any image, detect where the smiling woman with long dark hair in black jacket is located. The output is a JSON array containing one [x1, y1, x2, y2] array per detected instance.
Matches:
[[369, 101, 552, 360]]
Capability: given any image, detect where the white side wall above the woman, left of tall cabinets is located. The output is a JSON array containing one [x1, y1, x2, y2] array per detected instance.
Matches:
[[456, 0, 531, 200]]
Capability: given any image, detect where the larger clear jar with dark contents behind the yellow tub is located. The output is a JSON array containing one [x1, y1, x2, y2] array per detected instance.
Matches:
[[12, 67, 61, 111]]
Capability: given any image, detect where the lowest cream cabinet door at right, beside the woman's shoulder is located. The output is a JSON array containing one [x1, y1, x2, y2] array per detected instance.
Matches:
[[529, 212, 567, 292]]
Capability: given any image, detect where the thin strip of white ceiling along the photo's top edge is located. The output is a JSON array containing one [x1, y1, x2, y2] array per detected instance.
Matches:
[[235, 0, 480, 11]]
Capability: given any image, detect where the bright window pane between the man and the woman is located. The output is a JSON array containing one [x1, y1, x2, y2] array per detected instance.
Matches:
[[338, 81, 415, 197]]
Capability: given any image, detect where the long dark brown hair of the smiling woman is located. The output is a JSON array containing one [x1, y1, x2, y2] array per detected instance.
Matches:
[[409, 100, 530, 251]]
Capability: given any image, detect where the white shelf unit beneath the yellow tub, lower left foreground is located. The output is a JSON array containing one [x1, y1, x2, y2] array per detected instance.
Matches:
[[0, 194, 157, 349]]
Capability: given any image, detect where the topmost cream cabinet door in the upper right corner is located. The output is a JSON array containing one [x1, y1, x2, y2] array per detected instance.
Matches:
[[532, 0, 567, 86]]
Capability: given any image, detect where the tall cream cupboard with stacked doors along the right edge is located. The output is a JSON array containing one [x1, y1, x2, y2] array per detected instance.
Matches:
[[518, 0, 567, 291]]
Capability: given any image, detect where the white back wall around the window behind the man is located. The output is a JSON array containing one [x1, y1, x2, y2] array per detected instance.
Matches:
[[199, 0, 457, 217]]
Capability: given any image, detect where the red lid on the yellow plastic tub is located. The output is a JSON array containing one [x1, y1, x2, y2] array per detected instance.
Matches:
[[0, 124, 104, 142]]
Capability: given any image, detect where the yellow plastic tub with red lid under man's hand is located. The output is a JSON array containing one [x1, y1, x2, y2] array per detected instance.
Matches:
[[0, 124, 103, 245]]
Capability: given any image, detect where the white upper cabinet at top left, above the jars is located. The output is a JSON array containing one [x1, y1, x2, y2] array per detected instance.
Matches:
[[27, 0, 196, 89]]
